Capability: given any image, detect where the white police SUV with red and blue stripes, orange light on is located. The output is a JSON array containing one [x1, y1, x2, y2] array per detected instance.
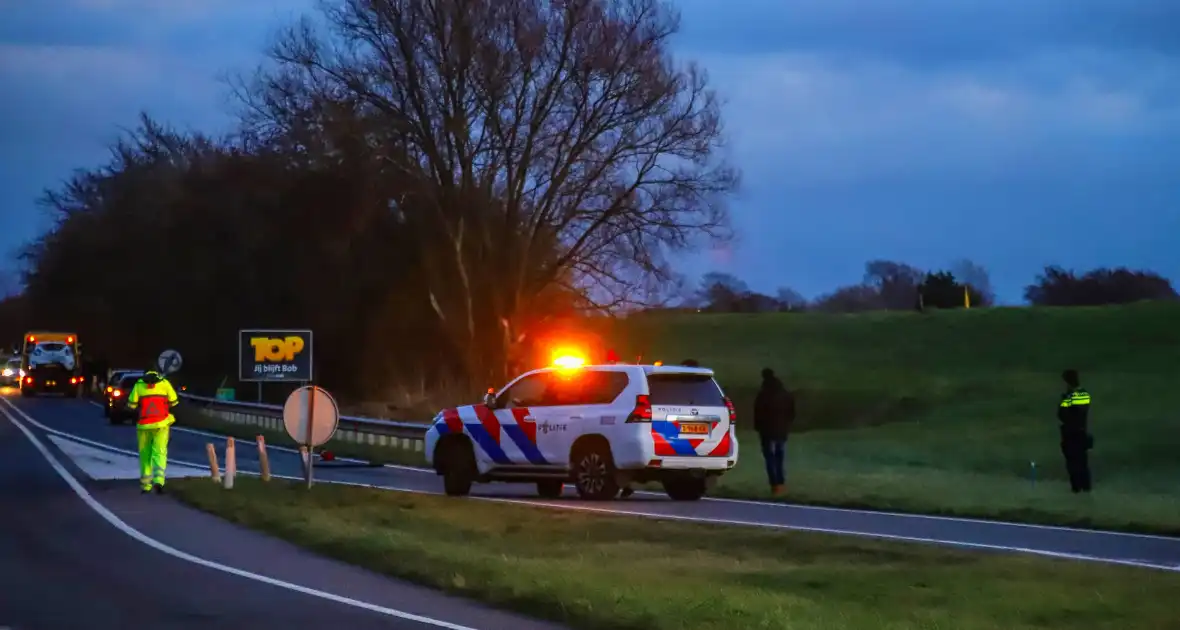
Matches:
[[425, 363, 738, 500]]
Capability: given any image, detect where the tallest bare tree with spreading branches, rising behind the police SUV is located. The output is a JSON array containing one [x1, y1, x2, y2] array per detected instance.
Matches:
[[248, 0, 739, 378]]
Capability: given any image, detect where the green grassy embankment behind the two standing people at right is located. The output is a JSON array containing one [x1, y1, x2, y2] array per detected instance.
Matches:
[[629, 303, 1180, 533]]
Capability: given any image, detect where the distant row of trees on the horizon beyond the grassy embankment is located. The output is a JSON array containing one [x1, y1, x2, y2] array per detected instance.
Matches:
[[679, 260, 1180, 313]]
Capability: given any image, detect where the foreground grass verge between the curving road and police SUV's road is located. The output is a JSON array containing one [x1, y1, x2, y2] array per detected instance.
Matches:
[[171, 477, 1180, 630]]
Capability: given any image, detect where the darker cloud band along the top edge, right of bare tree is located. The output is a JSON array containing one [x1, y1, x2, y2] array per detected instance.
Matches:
[[676, 0, 1180, 61]]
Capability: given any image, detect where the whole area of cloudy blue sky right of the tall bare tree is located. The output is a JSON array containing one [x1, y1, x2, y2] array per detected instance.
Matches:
[[660, 0, 1180, 300]]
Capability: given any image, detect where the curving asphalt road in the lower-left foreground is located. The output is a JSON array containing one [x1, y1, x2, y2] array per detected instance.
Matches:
[[0, 398, 566, 630]]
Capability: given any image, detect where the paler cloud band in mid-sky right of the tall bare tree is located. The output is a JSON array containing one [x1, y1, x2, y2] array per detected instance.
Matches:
[[703, 52, 1180, 183]]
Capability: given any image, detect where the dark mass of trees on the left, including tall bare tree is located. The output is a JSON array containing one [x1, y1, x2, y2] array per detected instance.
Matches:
[[0, 0, 739, 396]]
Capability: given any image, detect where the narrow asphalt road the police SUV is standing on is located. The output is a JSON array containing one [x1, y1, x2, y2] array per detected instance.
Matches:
[[13, 399, 1180, 571]]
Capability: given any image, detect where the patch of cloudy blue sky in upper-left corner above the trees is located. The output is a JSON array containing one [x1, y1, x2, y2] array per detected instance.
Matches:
[[0, 0, 310, 261]]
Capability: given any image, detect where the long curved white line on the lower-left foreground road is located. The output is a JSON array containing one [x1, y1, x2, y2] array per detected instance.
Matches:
[[0, 399, 477, 630]]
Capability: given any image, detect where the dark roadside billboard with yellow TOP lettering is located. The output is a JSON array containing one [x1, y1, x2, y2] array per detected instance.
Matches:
[[237, 329, 312, 381]]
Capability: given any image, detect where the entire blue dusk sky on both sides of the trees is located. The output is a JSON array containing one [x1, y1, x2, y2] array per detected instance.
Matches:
[[0, 0, 1180, 303]]
